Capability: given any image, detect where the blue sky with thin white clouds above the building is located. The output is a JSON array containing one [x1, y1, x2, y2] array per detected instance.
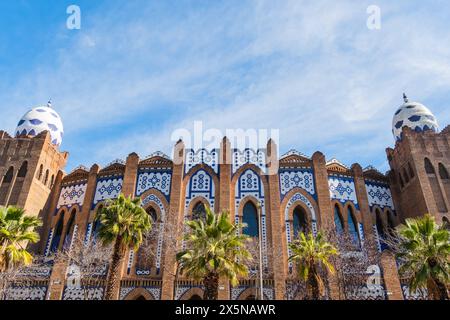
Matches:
[[0, 0, 450, 171]]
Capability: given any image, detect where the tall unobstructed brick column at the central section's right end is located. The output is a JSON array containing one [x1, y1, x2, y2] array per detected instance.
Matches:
[[266, 139, 288, 300]]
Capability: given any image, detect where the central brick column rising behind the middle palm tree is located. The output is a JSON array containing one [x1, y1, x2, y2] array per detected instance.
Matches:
[[219, 137, 234, 300]]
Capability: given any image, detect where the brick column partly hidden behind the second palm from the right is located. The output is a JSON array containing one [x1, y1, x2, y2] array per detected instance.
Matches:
[[312, 151, 340, 300]]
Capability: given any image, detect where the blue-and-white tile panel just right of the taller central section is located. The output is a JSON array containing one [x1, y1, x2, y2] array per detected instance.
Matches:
[[280, 169, 316, 198]]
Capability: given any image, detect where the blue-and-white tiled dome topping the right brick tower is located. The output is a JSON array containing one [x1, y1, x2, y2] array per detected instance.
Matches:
[[392, 95, 438, 141]]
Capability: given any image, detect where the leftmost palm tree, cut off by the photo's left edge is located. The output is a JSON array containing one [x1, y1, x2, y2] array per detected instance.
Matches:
[[0, 207, 42, 272]]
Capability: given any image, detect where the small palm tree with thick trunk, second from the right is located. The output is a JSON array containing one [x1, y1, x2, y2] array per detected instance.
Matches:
[[289, 232, 338, 300]]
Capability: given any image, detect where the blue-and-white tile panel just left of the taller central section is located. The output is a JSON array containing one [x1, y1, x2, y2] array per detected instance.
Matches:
[[136, 171, 172, 199]]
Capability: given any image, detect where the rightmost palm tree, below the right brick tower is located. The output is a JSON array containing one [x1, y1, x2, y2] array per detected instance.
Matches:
[[395, 215, 450, 300]]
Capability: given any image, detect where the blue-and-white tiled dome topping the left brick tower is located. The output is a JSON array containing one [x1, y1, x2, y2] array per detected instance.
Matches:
[[16, 102, 64, 146]]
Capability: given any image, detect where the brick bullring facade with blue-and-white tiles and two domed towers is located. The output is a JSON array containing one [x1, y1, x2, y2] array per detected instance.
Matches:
[[0, 97, 450, 300]]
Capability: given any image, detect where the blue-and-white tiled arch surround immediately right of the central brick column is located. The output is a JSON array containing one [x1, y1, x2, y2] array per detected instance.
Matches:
[[235, 169, 269, 268]]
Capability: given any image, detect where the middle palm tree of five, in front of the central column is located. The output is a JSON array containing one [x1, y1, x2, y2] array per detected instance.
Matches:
[[177, 208, 252, 300]]
